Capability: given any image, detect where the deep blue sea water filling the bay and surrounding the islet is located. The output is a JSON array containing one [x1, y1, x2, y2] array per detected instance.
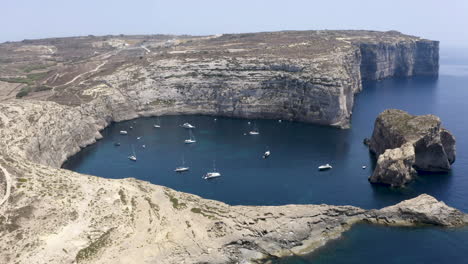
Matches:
[[64, 48, 468, 264]]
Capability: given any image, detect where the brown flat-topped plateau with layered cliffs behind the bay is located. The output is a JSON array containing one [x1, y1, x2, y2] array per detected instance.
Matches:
[[0, 31, 439, 128]]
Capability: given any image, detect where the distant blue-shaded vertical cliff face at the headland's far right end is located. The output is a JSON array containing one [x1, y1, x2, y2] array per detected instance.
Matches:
[[359, 40, 439, 80]]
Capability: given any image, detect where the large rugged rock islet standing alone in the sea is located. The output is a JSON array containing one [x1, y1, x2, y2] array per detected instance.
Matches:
[[368, 109, 455, 186]]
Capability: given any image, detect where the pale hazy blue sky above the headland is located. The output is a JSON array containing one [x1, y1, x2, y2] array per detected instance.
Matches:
[[0, 0, 468, 47]]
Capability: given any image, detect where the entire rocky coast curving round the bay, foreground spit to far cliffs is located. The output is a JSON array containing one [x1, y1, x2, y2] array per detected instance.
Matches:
[[0, 31, 458, 264]]
